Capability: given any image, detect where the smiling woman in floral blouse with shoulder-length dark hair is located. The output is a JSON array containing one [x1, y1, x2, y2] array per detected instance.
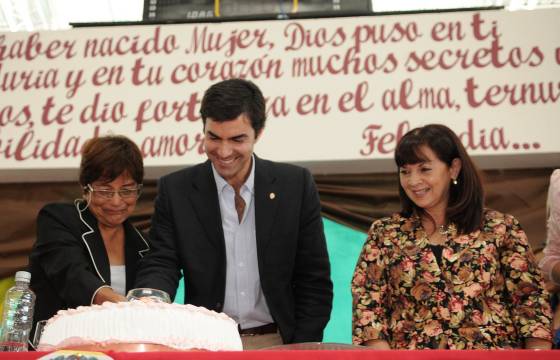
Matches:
[[352, 125, 551, 349]]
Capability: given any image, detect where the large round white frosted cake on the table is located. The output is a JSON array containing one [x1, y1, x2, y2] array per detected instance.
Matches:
[[39, 301, 243, 351]]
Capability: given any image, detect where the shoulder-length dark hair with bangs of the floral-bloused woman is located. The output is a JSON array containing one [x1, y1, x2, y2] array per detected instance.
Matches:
[[395, 124, 484, 234]]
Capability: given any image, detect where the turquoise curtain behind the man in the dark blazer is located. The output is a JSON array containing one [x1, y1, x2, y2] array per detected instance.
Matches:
[[175, 218, 366, 344]]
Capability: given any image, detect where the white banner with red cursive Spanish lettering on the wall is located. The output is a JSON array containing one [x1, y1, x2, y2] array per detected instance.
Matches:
[[0, 10, 560, 181]]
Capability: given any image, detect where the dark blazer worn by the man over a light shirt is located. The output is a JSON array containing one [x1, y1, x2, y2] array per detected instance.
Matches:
[[136, 156, 332, 343]]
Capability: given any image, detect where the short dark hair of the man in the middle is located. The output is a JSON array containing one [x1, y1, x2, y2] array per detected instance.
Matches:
[[200, 79, 266, 135]]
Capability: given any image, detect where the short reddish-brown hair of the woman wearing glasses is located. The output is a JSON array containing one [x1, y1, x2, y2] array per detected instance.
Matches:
[[79, 135, 144, 186]]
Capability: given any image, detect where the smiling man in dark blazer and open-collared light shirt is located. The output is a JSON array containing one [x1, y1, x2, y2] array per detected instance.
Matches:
[[137, 79, 332, 348]]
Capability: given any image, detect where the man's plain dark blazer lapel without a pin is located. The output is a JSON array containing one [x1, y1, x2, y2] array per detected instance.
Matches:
[[190, 160, 225, 250]]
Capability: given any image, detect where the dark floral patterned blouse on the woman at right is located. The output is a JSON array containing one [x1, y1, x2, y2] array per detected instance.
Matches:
[[352, 210, 551, 349]]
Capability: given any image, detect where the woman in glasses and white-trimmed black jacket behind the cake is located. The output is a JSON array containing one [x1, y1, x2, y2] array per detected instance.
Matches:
[[29, 136, 149, 334]]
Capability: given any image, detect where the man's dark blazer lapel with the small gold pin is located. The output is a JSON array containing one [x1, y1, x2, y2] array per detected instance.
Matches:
[[255, 155, 278, 258]]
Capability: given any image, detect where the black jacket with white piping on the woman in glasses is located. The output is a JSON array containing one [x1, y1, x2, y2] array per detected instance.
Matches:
[[29, 201, 149, 330]]
